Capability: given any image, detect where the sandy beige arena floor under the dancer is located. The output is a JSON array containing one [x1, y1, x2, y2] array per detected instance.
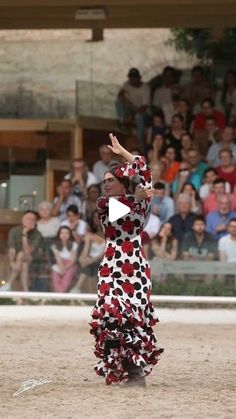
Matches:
[[0, 307, 236, 419]]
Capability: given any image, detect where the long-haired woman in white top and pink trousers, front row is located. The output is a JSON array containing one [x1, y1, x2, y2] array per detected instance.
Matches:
[[51, 226, 78, 292]]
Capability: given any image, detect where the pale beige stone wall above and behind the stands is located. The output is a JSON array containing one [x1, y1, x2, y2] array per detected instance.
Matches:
[[0, 29, 193, 117]]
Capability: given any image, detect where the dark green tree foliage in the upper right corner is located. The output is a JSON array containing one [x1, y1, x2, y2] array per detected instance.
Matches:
[[170, 28, 236, 63]]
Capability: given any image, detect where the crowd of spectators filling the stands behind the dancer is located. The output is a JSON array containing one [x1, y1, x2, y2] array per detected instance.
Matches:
[[2, 66, 236, 292]]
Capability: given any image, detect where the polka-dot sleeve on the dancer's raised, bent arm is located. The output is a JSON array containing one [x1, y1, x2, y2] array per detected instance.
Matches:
[[117, 156, 152, 189]]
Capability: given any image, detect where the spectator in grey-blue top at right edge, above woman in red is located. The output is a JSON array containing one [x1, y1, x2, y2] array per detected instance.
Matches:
[[206, 126, 236, 167]]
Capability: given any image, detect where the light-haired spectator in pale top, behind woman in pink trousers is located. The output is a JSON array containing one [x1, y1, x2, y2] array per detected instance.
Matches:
[[37, 201, 60, 248]]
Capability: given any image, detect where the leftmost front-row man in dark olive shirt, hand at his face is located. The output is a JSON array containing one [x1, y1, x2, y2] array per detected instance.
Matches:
[[1, 211, 42, 291]]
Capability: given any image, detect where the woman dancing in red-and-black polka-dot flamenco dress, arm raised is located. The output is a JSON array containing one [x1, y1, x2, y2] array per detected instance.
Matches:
[[90, 134, 163, 386]]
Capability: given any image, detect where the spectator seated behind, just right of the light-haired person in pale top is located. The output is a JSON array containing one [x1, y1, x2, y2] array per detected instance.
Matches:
[[52, 179, 81, 221]]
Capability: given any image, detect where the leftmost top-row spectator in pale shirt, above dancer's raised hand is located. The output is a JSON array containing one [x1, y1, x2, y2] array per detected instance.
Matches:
[[116, 68, 150, 148]]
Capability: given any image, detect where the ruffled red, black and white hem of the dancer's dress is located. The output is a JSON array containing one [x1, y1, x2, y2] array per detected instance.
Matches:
[[90, 296, 164, 384]]
